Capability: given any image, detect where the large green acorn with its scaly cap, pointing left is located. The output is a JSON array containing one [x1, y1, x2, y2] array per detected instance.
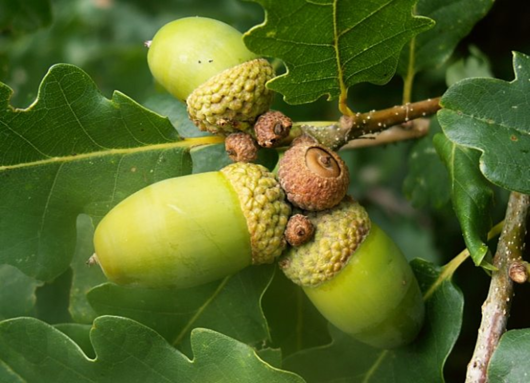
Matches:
[[94, 163, 291, 288]]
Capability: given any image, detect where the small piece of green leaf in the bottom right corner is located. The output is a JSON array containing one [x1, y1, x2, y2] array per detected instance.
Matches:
[[488, 329, 530, 383]]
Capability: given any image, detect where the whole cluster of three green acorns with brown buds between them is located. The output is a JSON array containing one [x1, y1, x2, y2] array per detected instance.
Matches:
[[88, 18, 424, 348]]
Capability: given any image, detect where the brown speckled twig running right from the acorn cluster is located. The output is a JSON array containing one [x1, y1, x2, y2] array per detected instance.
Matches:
[[290, 97, 441, 149]]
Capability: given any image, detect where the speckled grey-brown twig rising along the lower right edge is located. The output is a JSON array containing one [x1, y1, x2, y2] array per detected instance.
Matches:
[[466, 192, 530, 383]]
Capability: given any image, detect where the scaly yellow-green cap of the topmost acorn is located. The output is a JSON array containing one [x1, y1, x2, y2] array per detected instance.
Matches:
[[186, 59, 274, 134]]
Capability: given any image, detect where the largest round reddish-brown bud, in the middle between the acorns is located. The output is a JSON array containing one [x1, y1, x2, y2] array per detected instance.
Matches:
[[278, 143, 350, 211]]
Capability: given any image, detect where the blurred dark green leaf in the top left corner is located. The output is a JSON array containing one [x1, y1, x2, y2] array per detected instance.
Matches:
[[0, 0, 52, 35]]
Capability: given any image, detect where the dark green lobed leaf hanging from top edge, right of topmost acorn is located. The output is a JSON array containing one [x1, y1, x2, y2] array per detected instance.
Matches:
[[245, 0, 434, 104]]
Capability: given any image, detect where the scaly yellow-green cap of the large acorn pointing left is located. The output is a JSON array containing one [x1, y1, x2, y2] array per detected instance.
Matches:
[[221, 162, 291, 265]]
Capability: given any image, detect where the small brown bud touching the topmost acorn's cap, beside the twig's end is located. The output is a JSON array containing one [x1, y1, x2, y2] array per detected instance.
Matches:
[[254, 110, 293, 148]]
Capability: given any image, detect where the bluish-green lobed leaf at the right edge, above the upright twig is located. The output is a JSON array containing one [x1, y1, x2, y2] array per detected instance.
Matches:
[[438, 52, 530, 194]]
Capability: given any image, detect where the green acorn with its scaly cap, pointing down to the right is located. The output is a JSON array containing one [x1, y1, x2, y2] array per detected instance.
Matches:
[[279, 196, 425, 349]]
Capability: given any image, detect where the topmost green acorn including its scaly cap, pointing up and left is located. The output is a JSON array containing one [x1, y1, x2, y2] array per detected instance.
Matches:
[[147, 17, 274, 134]]
